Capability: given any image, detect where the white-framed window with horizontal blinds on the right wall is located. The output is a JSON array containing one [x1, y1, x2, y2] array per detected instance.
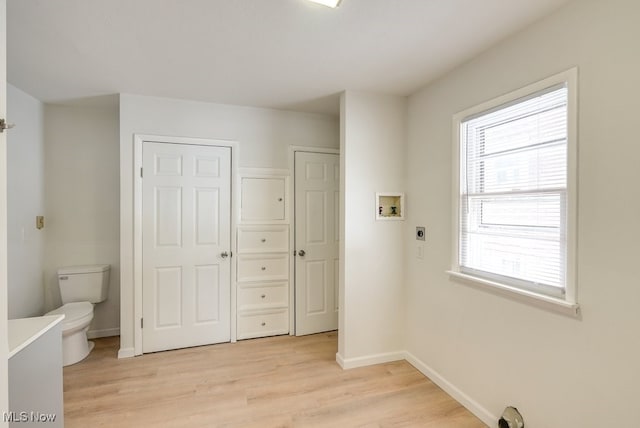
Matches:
[[453, 70, 576, 307]]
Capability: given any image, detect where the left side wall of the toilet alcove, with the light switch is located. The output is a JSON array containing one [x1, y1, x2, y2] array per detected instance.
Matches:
[[7, 85, 46, 319]]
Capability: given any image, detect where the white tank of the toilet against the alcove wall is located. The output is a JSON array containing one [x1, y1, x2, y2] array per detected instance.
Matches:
[[58, 265, 111, 303]]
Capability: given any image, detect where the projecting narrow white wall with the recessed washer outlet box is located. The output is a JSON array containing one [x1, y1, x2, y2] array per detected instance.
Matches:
[[337, 91, 407, 367]]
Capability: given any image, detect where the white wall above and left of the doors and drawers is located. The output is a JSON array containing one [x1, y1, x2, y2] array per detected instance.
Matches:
[[120, 94, 339, 356]]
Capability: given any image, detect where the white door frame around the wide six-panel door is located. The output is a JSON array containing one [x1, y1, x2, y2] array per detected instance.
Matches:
[[132, 134, 239, 355]]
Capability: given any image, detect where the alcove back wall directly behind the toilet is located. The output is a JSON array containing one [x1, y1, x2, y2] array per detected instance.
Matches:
[[45, 103, 120, 336]]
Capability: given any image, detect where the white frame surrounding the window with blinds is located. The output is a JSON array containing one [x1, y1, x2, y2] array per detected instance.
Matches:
[[447, 68, 579, 315]]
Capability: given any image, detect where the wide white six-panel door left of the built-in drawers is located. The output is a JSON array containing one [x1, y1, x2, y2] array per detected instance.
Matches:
[[142, 142, 231, 352]]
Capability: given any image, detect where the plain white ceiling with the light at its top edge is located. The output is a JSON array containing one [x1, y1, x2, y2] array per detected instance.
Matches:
[[7, 0, 567, 114]]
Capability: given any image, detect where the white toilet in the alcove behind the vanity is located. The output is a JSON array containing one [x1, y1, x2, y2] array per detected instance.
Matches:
[[47, 265, 110, 366]]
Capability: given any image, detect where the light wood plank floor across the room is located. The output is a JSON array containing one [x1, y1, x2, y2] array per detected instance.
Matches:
[[64, 332, 485, 428]]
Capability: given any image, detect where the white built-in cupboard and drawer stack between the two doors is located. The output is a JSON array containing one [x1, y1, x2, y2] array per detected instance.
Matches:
[[234, 168, 292, 340]]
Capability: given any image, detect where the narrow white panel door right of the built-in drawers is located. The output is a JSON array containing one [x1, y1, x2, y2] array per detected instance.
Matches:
[[295, 152, 340, 336]]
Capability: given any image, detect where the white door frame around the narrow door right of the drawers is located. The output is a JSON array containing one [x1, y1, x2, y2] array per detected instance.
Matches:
[[289, 146, 343, 336]]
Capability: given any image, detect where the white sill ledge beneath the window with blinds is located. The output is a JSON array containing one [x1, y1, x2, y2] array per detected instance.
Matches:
[[447, 271, 580, 317]]
